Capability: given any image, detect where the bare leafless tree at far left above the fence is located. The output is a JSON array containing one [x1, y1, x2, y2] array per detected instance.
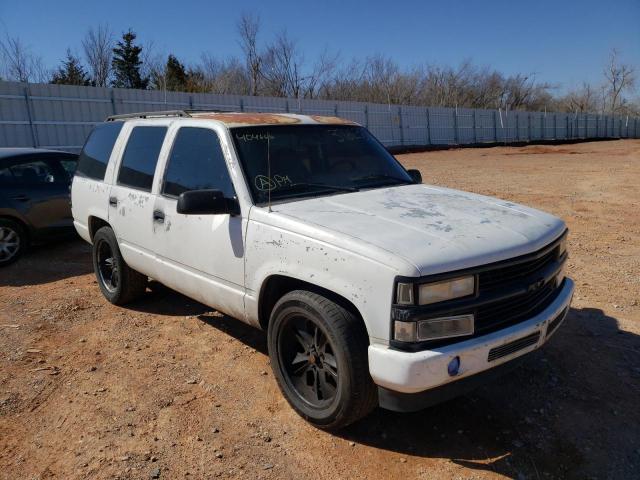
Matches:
[[0, 34, 50, 83]]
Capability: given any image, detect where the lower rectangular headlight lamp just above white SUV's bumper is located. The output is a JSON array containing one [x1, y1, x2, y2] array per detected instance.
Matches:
[[393, 314, 474, 342]]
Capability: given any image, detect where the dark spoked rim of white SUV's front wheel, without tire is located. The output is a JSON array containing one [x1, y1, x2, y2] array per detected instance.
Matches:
[[278, 316, 339, 408]]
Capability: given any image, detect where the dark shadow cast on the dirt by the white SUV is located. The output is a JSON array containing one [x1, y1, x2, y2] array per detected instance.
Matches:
[[116, 285, 640, 479]]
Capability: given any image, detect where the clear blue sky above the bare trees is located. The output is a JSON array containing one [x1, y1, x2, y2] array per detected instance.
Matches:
[[0, 0, 640, 90]]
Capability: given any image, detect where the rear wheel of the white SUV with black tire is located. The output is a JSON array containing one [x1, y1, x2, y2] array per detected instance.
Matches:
[[93, 227, 148, 305]]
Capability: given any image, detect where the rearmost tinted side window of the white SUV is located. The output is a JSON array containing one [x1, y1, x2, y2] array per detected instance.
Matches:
[[76, 122, 124, 180]]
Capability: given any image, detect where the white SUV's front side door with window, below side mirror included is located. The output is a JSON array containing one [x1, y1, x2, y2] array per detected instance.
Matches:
[[154, 122, 246, 318]]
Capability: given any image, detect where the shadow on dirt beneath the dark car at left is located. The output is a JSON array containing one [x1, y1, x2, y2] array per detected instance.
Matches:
[[0, 236, 93, 287]]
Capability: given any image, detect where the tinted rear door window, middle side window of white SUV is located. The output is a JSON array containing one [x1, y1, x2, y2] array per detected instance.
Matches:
[[118, 127, 167, 192]]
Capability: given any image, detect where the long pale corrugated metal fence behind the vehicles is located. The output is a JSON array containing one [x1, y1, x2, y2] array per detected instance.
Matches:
[[0, 82, 640, 151]]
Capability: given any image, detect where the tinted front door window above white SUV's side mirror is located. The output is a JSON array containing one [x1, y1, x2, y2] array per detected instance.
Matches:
[[162, 127, 235, 197]]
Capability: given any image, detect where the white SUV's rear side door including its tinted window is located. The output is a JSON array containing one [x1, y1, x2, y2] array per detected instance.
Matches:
[[109, 124, 167, 276]]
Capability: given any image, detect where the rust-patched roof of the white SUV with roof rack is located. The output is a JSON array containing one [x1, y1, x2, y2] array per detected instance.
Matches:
[[107, 110, 357, 127]]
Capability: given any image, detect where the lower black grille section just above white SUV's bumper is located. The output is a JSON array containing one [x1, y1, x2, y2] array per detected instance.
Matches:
[[475, 279, 559, 335]]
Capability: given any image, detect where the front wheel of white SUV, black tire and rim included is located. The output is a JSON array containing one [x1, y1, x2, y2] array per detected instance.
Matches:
[[268, 290, 377, 430]]
